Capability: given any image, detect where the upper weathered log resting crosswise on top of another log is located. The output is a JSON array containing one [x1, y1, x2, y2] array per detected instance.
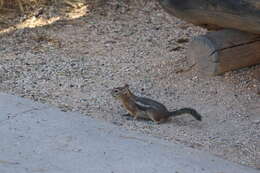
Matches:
[[158, 0, 260, 34]]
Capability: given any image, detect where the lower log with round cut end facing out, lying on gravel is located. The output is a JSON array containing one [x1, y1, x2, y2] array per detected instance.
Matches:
[[187, 29, 260, 75]]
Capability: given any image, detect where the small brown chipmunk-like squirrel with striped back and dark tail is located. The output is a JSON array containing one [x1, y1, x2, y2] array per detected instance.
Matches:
[[111, 84, 202, 123]]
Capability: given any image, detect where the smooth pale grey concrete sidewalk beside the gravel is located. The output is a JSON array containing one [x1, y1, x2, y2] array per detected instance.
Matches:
[[0, 94, 260, 173]]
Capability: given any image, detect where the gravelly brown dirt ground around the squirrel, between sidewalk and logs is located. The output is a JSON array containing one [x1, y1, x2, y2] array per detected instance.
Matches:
[[0, 0, 260, 168]]
